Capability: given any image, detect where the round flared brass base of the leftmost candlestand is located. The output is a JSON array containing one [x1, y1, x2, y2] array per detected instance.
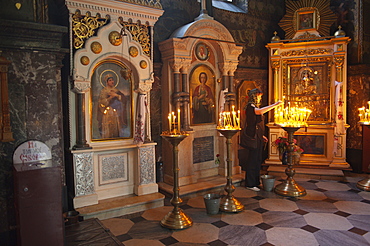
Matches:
[[161, 208, 193, 230]]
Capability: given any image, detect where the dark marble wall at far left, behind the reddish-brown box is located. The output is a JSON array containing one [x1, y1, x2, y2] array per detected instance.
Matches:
[[0, 21, 67, 241]]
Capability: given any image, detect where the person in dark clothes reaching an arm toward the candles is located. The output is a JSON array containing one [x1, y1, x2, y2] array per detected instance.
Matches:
[[239, 88, 283, 191]]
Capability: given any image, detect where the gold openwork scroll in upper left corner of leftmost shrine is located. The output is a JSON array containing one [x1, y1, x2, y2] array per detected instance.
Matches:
[[72, 10, 109, 49]]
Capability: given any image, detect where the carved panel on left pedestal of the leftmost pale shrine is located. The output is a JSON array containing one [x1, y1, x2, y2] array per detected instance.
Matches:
[[73, 153, 95, 196]]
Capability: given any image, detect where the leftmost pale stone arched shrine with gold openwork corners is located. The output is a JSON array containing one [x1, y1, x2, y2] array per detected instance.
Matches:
[[67, 0, 163, 209]]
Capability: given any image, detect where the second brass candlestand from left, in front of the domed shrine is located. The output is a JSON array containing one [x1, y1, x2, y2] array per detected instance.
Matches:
[[217, 129, 244, 213]]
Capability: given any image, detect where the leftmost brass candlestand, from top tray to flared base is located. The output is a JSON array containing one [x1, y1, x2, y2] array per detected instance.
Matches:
[[161, 134, 193, 230]]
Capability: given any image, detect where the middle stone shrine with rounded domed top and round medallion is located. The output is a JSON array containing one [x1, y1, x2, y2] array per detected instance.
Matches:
[[159, 16, 242, 186]]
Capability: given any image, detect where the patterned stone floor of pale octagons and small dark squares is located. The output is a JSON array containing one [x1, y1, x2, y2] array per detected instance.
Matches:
[[102, 177, 370, 246]]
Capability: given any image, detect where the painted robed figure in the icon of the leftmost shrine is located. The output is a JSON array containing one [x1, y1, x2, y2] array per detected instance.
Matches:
[[97, 73, 127, 138]]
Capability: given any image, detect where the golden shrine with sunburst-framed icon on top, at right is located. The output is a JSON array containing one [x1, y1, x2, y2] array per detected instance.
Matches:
[[266, 0, 350, 169]]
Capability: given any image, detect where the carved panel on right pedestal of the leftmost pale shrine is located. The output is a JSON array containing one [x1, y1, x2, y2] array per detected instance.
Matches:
[[139, 147, 155, 184]]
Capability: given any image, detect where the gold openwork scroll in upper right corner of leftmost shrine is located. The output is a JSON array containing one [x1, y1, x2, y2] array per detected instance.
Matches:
[[119, 18, 151, 57]]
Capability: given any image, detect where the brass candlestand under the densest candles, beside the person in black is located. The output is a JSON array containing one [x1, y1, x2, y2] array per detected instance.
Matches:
[[275, 127, 307, 197]]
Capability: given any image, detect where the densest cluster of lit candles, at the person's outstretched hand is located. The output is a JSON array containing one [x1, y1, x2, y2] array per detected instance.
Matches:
[[274, 102, 312, 127]]
